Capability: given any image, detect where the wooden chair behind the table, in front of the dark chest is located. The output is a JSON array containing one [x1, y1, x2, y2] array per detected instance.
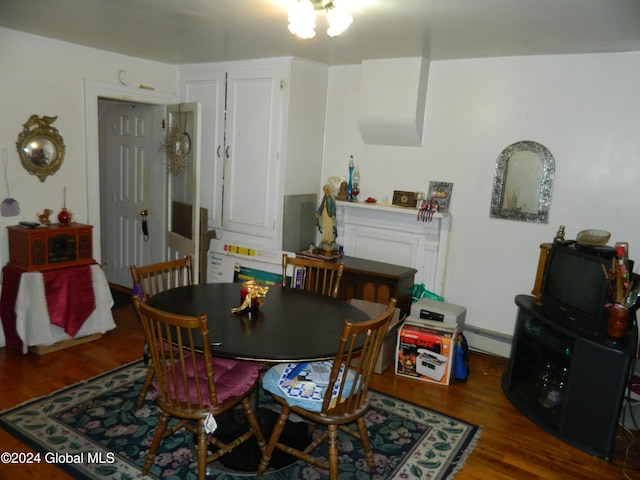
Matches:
[[282, 253, 344, 298]]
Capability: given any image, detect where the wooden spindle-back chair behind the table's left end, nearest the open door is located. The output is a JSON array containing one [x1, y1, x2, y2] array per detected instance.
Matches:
[[129, 255, 193, 410]]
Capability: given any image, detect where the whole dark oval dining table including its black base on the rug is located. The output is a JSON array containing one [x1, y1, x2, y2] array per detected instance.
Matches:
[[147, 283, 370, 477]]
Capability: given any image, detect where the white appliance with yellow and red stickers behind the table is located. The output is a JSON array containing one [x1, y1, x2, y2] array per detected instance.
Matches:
[[207, 239, 288, 285]]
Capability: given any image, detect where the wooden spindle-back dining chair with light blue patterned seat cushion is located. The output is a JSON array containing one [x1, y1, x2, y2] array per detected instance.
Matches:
[[257, 298, 396, 480]]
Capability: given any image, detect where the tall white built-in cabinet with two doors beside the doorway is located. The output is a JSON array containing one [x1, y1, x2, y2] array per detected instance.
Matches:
[[179, 58, 328, 248]]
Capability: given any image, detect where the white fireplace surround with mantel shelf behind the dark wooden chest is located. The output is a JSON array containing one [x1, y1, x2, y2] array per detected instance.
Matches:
[[336, 201, 451, 296]]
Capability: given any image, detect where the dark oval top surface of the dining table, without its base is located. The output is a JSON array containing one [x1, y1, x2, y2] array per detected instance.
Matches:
[[147, 283, 370, 362]]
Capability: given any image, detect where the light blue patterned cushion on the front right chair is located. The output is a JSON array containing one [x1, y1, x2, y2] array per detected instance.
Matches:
[[262, 362, 354, 412]]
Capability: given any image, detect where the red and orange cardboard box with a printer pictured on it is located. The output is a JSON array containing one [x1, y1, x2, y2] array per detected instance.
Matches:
[[395, 316, 459, 385]]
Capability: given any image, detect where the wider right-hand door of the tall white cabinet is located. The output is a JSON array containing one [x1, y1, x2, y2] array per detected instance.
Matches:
[[222, 66, 283, 238]]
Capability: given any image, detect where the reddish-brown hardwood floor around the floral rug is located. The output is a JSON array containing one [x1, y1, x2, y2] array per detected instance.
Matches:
[[0, 307, 640, 480]]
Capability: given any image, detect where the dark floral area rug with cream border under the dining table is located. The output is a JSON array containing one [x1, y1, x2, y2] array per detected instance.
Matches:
[[0, 361, 481, 480]]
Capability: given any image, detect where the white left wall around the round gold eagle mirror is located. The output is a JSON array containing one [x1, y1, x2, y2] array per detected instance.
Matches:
[[0, 28, 175, 265]]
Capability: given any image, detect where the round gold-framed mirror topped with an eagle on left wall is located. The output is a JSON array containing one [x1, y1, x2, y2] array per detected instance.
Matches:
[[16, 115, 64, 182]]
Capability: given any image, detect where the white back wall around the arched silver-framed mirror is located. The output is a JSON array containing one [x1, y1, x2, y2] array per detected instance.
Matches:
[[323, 54, 640, 334]]
